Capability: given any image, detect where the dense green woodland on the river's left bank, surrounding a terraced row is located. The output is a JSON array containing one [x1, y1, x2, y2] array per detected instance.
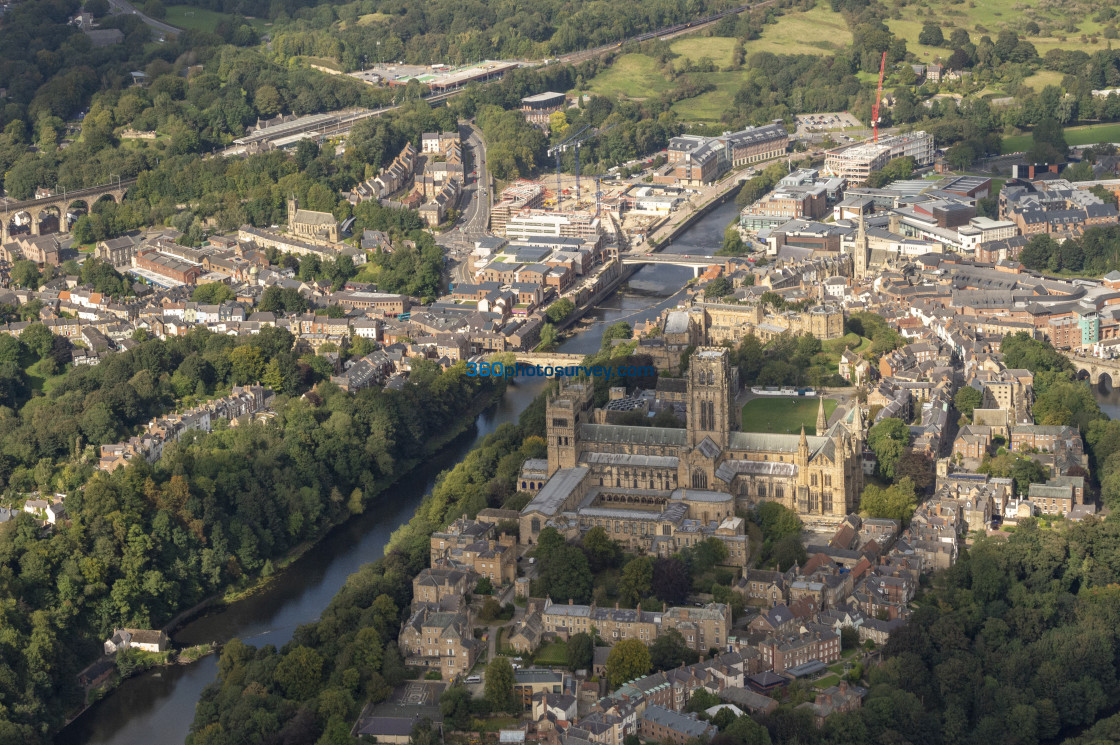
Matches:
[[0, 330, 501, 745]]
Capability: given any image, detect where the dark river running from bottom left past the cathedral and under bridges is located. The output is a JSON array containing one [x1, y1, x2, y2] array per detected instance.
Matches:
[[55, 192, 738, 745]]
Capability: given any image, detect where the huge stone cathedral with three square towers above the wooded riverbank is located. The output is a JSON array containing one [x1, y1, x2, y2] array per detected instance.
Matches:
[[521, 347, 864, 555]]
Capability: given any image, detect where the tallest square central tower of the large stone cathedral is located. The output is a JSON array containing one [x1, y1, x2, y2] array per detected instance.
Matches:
[[688, 346, 738, 443]]
